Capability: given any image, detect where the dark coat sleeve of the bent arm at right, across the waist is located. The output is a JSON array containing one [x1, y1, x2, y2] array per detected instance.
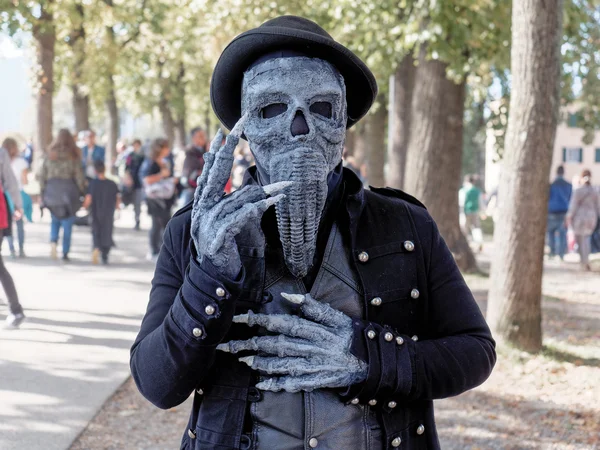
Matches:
[[344, 213, 496, 402]]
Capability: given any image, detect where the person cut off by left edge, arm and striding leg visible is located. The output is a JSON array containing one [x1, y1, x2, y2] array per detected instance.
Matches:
[[0, 139, 25, 328]]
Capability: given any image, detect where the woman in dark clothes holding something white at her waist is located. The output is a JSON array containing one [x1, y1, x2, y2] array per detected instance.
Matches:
[[143, 138, 176, 261]]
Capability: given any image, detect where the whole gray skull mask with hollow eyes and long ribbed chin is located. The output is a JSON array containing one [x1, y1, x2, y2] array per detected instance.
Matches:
[[242, 56, 347, 277]]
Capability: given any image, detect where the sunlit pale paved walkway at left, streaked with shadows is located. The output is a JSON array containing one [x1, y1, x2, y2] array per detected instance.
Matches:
[[0, 211, 153, 450]]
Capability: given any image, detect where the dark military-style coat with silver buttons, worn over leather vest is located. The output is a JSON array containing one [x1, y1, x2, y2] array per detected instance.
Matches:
[[131, 171, 495, 450]]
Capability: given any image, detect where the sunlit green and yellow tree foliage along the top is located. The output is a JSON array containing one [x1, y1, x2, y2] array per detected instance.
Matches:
[[0, 0, 600, 148]]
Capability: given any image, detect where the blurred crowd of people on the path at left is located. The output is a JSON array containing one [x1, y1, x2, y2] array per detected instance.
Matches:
[[0, 127, 254, 328]]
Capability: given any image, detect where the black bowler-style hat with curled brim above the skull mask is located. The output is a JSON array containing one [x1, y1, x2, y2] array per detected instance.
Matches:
[[210, 16, 377, 130]]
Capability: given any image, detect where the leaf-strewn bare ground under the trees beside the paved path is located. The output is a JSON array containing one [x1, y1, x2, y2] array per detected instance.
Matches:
[[71, 250, 600, 450]]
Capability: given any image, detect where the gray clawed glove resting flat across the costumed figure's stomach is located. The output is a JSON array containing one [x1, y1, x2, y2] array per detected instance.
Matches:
[[217, 293, 367, 392]]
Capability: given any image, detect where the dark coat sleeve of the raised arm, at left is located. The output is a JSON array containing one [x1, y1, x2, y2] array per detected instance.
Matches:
[[130, 221, 243, 409]]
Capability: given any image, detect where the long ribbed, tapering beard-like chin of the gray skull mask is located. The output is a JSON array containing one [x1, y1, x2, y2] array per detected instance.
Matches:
[[269, 148, 329, 278]]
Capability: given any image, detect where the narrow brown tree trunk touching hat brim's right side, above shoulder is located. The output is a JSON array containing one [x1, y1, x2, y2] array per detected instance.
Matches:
[[366, 95, 387, 187]]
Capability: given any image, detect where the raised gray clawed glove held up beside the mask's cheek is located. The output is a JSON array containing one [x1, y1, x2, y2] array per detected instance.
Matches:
[[191, 115, 291, 279]]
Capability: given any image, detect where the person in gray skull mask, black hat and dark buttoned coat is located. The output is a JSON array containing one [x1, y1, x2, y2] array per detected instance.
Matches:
[[131, 16, 495, 450]]
